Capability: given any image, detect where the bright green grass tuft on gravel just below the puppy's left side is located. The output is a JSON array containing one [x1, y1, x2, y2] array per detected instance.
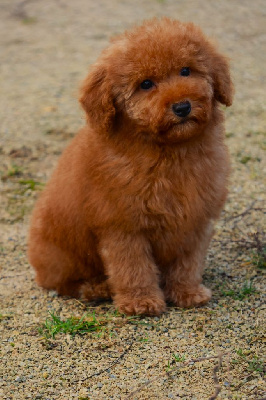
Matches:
[[39, 312, 102, 338]]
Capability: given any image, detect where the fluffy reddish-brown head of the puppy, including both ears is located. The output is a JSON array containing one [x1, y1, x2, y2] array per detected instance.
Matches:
[[80, 18, 233, 143]]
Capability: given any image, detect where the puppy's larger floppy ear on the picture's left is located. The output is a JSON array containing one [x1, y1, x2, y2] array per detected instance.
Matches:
[[79, 65, 115, 133]]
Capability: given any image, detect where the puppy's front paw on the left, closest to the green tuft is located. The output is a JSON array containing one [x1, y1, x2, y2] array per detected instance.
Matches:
[[114, 295, 166, 315]]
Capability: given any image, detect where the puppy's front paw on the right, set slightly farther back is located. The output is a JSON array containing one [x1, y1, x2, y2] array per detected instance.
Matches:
[[166, 285, 212, 308]]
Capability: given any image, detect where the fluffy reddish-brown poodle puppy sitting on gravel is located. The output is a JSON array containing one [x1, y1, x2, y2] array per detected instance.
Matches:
[[28, 18, 233, 315]]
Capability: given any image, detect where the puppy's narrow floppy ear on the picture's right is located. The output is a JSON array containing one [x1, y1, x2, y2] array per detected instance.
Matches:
[[212, 52, 234, 107]]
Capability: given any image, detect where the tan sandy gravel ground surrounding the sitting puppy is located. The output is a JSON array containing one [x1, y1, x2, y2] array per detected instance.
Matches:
[[0, 0, 266, 400]]
